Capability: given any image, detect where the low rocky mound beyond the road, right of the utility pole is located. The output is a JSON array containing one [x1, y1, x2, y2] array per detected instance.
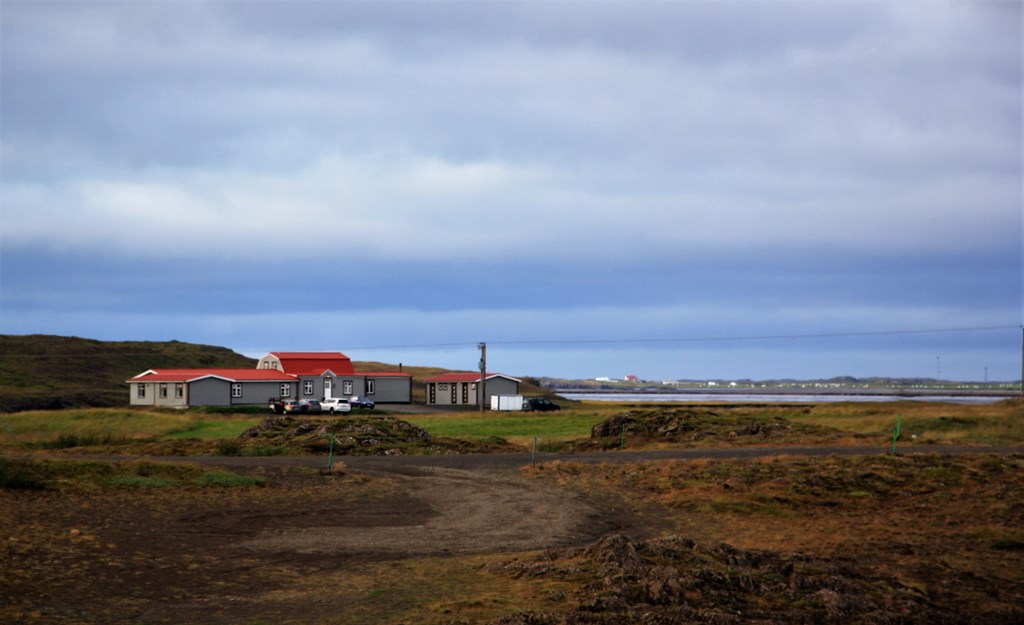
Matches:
[[590, 408, 849, 447]]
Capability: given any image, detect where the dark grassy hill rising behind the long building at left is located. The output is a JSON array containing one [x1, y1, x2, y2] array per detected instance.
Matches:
[[0, 334, 256, 412]]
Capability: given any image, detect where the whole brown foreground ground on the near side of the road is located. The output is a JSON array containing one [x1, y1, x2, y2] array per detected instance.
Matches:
[[0, 446, 1024, 625]]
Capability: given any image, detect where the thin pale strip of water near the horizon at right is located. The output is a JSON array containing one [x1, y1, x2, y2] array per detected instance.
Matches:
[[558, 390, 1007, 404]]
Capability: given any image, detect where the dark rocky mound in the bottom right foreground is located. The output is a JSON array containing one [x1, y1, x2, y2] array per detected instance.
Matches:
[[493, 535, 983, 625]]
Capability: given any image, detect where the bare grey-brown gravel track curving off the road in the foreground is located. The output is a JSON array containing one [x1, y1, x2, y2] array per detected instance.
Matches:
[[236, 467, 622, 558]]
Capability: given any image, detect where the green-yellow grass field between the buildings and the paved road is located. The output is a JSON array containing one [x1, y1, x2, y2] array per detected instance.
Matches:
[[0, 400, 1024, 449]]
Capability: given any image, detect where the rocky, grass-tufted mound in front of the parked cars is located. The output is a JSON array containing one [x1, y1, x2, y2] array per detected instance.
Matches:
[[239, 415, 522, 456]]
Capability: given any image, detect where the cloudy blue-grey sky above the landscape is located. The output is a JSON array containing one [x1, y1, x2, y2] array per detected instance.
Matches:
[[0, 0, 1024, 381]]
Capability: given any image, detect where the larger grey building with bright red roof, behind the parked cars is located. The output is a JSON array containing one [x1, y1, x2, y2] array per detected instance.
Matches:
[[127, 351, 413, 408]]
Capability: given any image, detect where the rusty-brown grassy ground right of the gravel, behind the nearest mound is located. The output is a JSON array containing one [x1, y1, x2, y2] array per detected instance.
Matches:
[[524, 455, 1024, 614]]
